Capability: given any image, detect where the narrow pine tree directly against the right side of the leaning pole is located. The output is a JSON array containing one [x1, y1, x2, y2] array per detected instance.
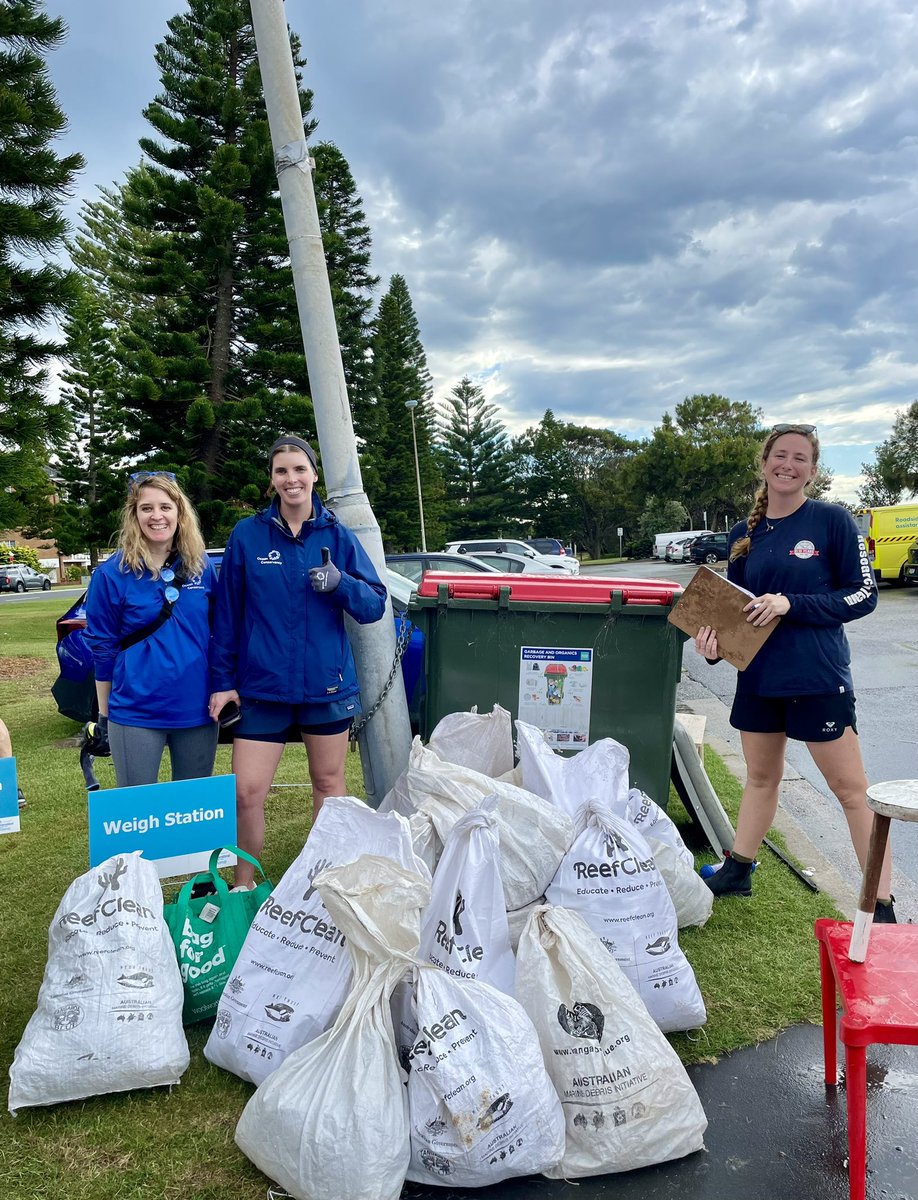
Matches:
[[312, 142, 379, 438]]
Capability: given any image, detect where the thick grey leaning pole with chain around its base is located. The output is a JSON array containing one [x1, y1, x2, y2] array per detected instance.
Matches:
[[251, 0, 412, 806]]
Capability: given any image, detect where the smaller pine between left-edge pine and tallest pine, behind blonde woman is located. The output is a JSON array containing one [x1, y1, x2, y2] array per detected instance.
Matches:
[[53, 281, 125, 566]]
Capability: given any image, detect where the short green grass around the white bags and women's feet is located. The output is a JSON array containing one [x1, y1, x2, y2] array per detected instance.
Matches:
[[0, 598, 838, 1200]]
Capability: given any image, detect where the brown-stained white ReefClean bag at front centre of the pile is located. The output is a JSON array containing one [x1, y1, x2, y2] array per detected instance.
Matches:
[[396, 967, 564, 1188]]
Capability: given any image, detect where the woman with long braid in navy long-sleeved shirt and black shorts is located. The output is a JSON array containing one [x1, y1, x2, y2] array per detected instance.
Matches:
[[695, 425, 895, 923]]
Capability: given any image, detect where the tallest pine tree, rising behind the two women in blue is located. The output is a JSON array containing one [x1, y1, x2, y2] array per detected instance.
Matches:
[[111, 0, 314, 538]]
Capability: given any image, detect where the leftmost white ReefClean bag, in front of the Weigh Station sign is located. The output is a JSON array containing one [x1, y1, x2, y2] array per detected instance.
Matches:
[[7, 851, 188, 1112]]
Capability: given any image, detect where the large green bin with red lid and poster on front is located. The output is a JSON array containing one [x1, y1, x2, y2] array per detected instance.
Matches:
[[410, 571, 685, 808]]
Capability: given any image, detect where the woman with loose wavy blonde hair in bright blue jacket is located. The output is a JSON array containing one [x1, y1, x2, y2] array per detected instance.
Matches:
[[86, 472, 217, 787]]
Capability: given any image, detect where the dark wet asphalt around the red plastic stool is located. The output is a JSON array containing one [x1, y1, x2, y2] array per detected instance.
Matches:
[[402, 1022, 918, 1200]]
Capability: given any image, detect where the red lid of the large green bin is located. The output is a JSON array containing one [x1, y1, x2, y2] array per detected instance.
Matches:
[[418, 571, 682, 606]]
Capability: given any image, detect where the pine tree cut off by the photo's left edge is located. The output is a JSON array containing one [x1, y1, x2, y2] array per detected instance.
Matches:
[[0, 0, 83, 528]]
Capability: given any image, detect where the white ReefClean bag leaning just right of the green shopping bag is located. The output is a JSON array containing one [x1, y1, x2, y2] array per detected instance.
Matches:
[[204, 796, 426, 1084]]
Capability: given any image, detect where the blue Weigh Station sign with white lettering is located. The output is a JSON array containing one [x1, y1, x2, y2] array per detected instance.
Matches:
[[89, 775, 236, 878]]
